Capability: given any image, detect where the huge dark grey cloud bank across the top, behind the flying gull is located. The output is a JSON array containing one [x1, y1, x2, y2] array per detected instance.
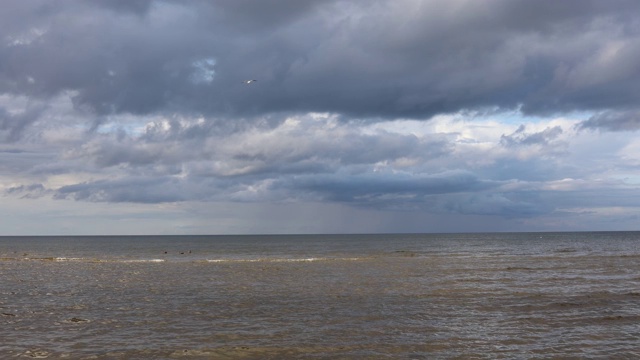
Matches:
[[0, 0, 640, 118]]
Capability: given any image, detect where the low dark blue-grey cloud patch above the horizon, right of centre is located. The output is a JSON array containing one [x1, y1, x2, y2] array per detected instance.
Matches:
[[273, 171, 554, 218]]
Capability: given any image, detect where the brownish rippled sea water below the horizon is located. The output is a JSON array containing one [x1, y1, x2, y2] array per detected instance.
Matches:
[[0, 232, 640, 359]]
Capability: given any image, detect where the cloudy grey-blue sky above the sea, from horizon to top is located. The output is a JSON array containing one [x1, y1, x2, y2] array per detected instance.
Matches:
[[0, 0, 640, 235]]
